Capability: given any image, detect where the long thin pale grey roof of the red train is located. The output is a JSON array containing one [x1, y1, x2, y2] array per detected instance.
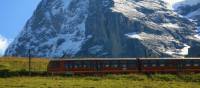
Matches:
[[48, 58, 200, 61]]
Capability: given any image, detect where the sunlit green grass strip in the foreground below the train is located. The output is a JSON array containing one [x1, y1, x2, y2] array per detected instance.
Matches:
[[0, 75, 200, 88]]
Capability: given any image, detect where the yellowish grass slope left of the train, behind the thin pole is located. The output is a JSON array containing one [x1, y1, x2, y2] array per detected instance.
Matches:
[[0, 57, 49, 72]]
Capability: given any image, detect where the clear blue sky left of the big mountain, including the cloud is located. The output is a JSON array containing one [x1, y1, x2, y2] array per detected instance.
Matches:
[[0, 0, 41, 55]]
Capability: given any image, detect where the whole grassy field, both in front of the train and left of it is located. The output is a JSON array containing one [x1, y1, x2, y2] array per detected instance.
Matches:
[[0, 58, 200, 88]]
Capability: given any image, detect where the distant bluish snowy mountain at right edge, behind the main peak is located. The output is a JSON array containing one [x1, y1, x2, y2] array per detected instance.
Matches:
[[173, 0, 200, 57]]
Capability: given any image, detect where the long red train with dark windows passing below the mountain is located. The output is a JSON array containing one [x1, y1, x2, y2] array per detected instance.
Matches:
[[48, 58, 200, 74]]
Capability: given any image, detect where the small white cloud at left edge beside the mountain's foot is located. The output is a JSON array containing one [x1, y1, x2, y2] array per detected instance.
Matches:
[[0, 35, 10, 56]]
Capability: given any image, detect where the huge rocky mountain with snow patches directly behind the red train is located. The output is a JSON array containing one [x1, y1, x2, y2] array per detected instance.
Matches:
[[5, 0, 200, 58]]
